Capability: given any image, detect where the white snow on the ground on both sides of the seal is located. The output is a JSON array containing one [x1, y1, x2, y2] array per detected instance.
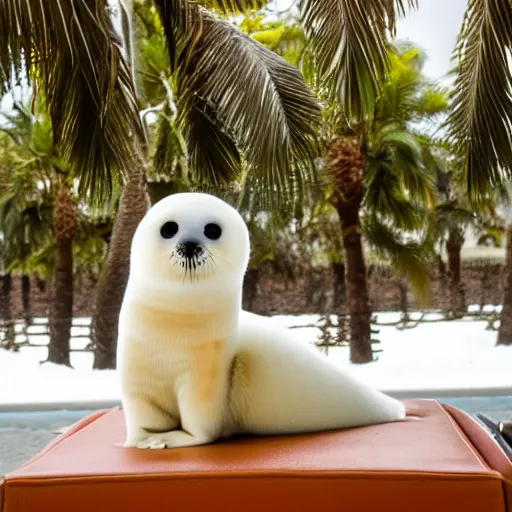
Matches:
[[0, 313, 512, 409]]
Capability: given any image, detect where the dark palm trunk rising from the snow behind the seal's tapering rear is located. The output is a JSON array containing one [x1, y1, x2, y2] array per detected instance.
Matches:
[[337, 203, 373, 363]]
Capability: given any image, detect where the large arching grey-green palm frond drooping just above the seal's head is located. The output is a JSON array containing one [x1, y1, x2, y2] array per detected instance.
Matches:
[[177, 9, 320, 209]]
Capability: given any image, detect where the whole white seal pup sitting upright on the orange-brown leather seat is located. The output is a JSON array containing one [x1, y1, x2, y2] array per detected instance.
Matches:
[[118, 193, 405, 448]]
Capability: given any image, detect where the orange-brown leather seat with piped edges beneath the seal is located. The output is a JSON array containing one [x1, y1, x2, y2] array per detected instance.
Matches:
[[0, 400, 512, 512]]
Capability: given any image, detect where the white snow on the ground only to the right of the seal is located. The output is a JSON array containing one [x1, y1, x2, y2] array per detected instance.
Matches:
[[274, 314, 512, 394]]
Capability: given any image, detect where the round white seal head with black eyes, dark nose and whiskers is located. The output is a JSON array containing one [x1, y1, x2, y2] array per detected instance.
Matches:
[[130, 193, 250, 300]]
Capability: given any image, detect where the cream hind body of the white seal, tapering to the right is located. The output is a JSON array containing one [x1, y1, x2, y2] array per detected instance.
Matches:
[[230, 311, 405, 434]]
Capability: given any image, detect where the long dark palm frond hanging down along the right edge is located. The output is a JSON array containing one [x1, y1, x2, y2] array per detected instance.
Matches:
[[448, 0, 512, 200]]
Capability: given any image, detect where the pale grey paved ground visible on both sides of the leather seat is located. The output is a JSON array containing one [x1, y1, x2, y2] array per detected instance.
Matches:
[[0, 397, 512, 476]]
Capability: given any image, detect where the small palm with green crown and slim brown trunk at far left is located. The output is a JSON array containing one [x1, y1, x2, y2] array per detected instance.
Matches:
[[0, 105, 77, 366]]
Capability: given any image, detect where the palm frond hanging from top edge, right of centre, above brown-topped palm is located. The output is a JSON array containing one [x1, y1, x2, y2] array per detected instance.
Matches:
[[298, 0, 416, 119]]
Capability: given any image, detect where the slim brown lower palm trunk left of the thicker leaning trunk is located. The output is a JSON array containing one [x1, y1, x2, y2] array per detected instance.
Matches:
[[47, 237, 73, 366]]
